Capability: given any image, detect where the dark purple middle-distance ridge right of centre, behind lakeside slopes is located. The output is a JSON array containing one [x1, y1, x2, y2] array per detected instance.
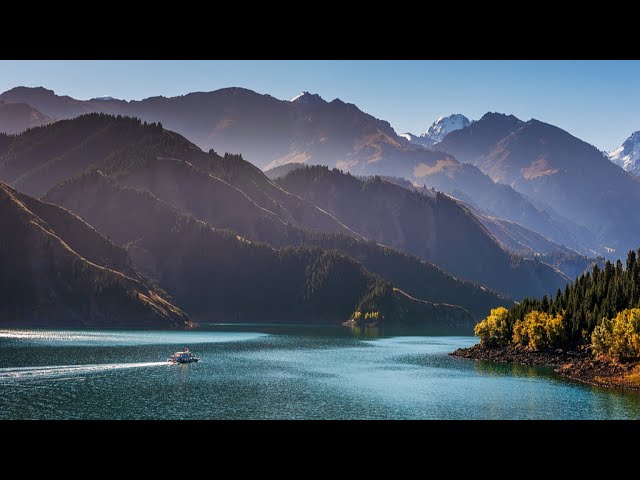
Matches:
[[278, 166, 567, 298]]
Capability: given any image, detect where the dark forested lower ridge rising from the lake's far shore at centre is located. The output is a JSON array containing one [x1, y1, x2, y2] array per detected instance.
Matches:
[[47, 171, 474, 328]]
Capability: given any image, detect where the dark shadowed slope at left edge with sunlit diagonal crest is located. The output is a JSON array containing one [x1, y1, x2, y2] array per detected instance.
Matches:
[[0, 178, 193, 328]]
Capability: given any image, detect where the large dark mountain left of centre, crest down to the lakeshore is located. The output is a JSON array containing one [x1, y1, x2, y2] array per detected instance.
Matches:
[[0, 114, 510, 328]]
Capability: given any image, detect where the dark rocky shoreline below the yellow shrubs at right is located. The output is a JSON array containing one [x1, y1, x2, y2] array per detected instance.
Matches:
[[451, 344, 640, 390]]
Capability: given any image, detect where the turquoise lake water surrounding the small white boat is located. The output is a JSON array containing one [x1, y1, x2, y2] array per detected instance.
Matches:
[[0, 326, 640, 419]]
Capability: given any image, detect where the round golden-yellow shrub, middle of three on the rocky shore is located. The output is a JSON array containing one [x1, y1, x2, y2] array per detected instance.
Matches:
[[513, 310, 566, 350]]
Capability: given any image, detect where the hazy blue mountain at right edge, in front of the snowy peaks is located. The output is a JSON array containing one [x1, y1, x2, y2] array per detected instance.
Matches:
[[434, 113, 640, 256]]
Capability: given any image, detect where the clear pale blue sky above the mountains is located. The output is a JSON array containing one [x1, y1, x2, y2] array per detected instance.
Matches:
[[0, 60, 640, 150]]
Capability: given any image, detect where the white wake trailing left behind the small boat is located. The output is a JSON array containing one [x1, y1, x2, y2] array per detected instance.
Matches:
[[0, 362, 170, 382]]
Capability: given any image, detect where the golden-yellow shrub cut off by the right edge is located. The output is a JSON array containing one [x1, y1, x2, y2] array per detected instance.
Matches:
[[591, 308, 640, 361]]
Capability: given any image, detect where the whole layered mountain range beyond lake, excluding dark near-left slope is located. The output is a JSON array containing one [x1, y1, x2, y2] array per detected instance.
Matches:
[[0, 87, 640, 327]]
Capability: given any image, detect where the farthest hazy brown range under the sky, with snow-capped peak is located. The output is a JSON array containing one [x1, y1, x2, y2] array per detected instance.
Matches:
[[0, 87, 615, 256]]
